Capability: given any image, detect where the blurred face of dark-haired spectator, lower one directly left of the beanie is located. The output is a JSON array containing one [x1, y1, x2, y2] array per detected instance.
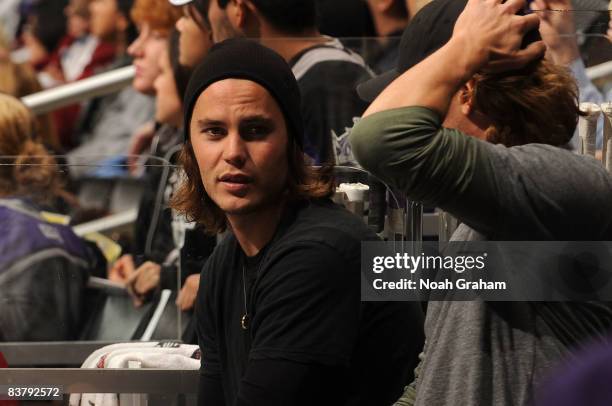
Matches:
[[153, 49, 182, 127]]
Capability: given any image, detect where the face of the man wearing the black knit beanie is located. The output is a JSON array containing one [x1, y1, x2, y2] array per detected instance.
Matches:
[[190, 79, 288, 215]]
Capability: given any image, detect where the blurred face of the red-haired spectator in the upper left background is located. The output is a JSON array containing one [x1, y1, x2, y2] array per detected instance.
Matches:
[[128, 22, 168, 94]]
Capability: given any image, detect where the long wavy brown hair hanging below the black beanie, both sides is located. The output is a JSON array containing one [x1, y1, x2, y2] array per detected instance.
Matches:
[[170, 132, 334, 234]]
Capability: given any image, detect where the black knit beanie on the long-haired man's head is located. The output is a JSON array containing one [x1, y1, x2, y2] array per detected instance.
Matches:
[[183, 38, 304, 148]]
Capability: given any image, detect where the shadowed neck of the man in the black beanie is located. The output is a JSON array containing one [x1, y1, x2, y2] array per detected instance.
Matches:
[[227, 202, 285, 257]]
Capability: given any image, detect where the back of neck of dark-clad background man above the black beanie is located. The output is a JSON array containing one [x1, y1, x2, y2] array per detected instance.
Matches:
[[260, 26, 329, 62]]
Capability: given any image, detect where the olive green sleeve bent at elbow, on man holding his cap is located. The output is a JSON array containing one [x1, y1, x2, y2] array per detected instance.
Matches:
[[350, 107, 498, 238]]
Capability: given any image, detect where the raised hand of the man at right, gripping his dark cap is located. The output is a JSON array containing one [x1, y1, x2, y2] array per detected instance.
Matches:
[[450, 0, 546, 73]]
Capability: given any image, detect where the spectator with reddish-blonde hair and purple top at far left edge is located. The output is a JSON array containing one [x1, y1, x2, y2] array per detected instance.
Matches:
[[0, 94, 98, 341]]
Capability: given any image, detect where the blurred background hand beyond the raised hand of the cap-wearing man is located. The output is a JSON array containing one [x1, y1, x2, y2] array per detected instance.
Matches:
[[531, 0, 580, 66]]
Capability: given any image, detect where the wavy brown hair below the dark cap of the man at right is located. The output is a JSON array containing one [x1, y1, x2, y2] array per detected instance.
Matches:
[[472, 60, 580, 146]]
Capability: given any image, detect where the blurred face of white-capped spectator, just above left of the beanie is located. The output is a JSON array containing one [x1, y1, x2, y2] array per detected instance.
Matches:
[[176, 5, 212, 68]]
